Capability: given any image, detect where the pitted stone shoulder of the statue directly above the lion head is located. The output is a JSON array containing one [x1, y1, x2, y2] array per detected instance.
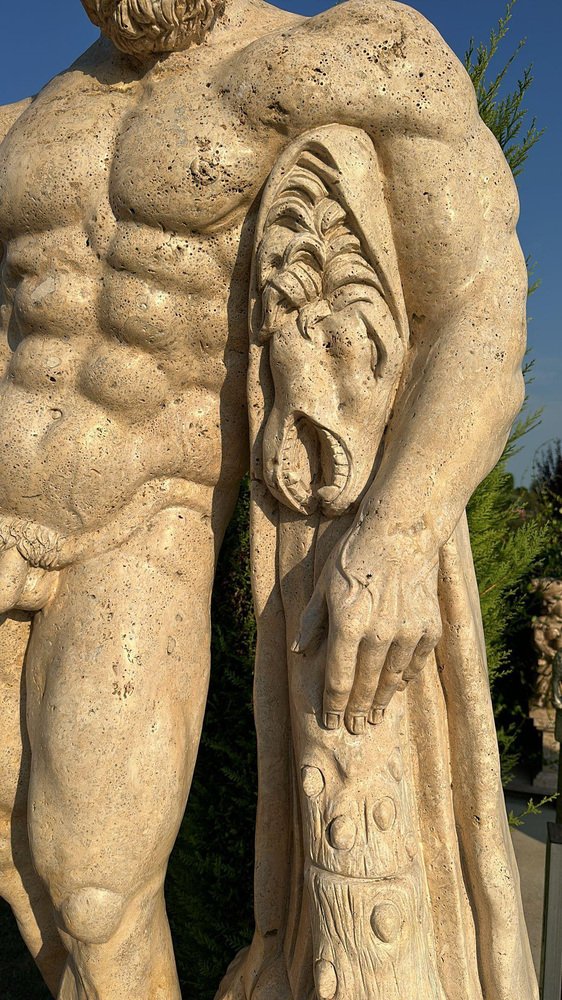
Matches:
[[244, 0, 478, 144]]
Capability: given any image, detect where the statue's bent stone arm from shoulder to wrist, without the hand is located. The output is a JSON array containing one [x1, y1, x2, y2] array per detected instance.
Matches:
[[272, 0, 527, 532]]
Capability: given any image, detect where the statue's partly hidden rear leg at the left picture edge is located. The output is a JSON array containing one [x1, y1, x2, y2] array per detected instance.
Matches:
[[0, 611, 66, 994]]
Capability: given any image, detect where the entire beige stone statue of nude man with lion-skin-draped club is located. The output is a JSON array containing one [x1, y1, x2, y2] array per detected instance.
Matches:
[[0, 0, 538, 1000]]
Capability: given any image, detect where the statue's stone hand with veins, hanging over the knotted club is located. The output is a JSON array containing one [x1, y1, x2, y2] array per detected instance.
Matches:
[[293, 523, 442, 735]]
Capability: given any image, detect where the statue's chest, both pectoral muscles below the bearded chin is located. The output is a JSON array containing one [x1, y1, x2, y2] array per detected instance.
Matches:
[[0, 73, 274, 246]]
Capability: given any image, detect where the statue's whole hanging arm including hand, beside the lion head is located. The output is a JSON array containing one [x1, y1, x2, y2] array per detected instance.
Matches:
[[296, 3, 527, 732]]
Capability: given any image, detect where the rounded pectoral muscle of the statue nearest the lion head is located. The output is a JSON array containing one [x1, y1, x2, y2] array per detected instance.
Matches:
[[110, 81, 268, 233]]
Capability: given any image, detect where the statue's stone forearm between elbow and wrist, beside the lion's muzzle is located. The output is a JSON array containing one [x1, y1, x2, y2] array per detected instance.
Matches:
[[363, 278, 524, 544]]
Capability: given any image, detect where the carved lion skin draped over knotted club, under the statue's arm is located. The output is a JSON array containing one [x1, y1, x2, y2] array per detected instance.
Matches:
[[217, 124, 540, 1000]]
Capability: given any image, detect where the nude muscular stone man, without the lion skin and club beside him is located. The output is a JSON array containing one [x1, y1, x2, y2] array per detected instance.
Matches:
[[0, 0, 526, 1000]]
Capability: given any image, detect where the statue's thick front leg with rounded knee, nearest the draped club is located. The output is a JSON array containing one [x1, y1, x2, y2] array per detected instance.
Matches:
[[23, 509, 214, 1000]]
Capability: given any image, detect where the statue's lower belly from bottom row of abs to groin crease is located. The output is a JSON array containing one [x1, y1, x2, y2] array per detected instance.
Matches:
[[0, 304, 245, 536]]
